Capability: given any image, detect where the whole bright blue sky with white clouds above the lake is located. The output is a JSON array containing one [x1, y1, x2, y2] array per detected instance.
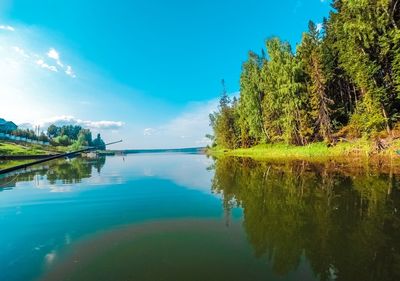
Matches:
[[0, 0, 330, 148]]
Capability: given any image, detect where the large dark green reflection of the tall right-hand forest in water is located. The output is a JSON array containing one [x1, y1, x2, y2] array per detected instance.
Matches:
[[212, 158, 400, 281]]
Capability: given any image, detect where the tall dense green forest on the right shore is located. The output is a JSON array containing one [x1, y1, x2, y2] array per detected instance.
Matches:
[[209, 0, 400, 148]]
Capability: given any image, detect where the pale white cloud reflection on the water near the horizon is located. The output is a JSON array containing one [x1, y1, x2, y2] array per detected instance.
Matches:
[[3, 153, 213, 193]]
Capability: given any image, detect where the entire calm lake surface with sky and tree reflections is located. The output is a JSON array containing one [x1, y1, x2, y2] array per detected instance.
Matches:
[[0, 153, 400, 281]]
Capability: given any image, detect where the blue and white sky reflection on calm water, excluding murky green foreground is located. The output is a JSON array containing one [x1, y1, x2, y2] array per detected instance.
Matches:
[[0, 154, 224, 281]]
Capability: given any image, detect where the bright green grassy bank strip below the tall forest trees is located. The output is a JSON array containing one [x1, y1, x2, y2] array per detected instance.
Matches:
[[206, 139, 400, 161]]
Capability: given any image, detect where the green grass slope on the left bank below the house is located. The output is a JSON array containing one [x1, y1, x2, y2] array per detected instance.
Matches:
[[0, 141, 63, 155]]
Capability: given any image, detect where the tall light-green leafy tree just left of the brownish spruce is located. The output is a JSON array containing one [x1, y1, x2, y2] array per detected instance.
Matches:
[[263, 38, 307, 145]]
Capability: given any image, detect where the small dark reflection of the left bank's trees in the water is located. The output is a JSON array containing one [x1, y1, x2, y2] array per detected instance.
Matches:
[[0, 157, 106, 187]]
